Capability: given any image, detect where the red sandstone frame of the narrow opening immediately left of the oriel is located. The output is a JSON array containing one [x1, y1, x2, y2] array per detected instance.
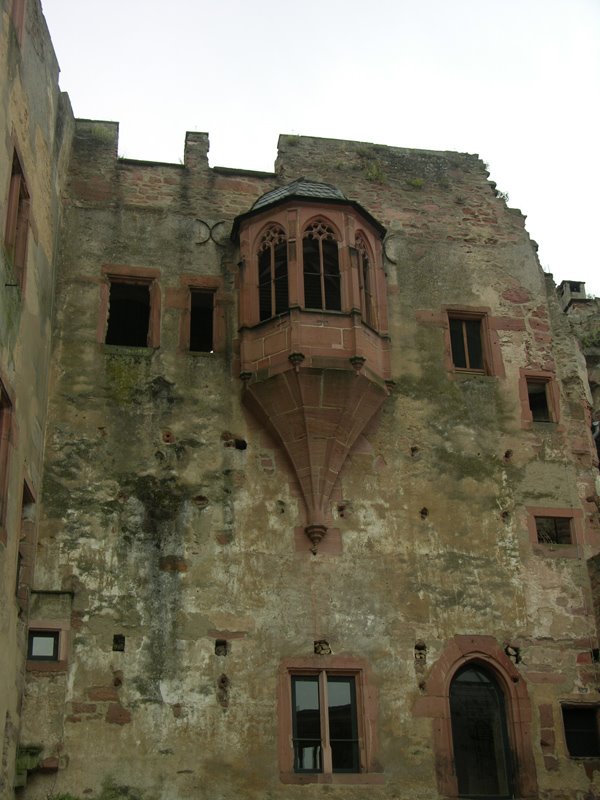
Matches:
[[178, 275, 226, 356]]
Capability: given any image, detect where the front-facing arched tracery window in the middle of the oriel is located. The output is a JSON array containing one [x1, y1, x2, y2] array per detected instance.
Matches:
[[302, 220, 342, 311]]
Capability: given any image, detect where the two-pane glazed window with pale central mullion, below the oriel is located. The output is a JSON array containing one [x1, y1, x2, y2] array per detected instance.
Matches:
[[291, 670, 360, 772]]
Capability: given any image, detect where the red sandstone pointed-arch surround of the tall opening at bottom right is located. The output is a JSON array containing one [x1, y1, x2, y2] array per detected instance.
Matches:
[[413, 634, 538, 800]]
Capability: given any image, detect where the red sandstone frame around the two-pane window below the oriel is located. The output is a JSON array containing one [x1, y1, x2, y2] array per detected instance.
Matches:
[[277, 655, 384, 784]]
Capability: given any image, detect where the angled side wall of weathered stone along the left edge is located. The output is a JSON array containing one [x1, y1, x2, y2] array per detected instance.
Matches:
[[0, 0, 73, 797]]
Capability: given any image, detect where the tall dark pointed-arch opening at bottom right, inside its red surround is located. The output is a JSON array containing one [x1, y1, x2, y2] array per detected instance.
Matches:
[[450, 664, 513, 798]]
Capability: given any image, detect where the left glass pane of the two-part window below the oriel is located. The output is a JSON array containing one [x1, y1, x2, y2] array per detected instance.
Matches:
[[292, 675, 321, 772]]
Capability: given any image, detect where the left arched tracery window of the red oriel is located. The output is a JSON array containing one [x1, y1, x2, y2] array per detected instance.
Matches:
[[258, 225, 289, 322]]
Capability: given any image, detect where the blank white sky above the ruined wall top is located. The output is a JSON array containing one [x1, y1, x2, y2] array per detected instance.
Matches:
[[42, 0, 600, 295]]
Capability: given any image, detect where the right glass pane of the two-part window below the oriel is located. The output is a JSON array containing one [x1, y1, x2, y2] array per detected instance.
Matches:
[[327, 676, 359, 772]]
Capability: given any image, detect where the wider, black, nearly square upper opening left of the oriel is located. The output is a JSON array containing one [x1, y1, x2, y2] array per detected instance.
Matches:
[[106, 281, 150, 347]]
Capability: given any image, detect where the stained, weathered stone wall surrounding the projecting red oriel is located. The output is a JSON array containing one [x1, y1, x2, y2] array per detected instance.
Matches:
[[15, 121, 600, 800]]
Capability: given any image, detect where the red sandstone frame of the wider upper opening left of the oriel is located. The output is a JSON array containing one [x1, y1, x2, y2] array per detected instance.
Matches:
[[96, 264, 161, 350]]
